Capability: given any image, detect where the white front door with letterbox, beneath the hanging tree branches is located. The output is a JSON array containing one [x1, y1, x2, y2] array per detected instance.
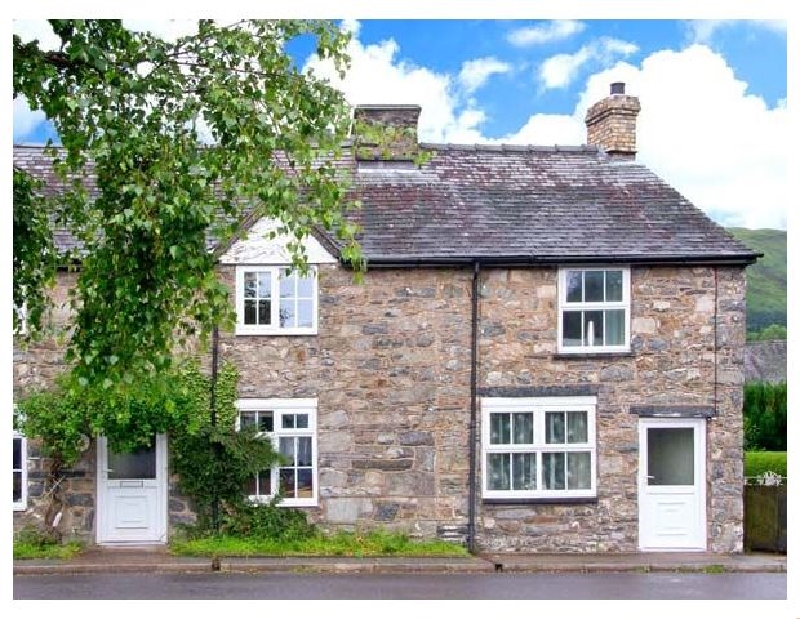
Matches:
[[97, 434, 167, 544]]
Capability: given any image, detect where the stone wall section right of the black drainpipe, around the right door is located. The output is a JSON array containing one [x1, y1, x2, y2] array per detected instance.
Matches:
[[479, 268, 745, 552]]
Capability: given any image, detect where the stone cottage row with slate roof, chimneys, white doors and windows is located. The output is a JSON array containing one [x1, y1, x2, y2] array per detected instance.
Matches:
[[14, 84, 758, 552]]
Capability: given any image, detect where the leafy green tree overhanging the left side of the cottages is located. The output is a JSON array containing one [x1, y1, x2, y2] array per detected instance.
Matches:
[[13, 20, 363, 396]]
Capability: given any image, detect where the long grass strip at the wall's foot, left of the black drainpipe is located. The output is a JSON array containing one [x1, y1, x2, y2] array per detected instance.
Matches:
[[170, 531, 468, 557]]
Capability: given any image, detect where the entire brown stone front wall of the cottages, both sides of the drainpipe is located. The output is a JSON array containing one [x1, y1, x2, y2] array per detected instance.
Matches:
[[14, 265, 745, 552]]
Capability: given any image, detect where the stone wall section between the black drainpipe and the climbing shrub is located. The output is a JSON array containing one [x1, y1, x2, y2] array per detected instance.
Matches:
[[220, 265, 471, 535]]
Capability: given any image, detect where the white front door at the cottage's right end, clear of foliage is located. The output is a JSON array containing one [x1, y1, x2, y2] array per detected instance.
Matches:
[[639, 419, 706, 550]]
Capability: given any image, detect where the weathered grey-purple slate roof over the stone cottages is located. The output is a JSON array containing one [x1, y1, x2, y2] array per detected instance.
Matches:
[[14, 144, 760, 264]]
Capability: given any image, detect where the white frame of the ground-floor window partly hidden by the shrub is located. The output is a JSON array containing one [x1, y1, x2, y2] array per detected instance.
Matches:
[[236, 398, 319, 507]]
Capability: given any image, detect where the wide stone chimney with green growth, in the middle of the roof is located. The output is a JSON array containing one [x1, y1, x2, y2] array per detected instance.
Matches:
[[353, 104, 422, 161]]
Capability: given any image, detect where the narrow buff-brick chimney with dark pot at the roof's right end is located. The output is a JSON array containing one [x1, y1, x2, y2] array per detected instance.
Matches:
[[586, 82, 641, 159]]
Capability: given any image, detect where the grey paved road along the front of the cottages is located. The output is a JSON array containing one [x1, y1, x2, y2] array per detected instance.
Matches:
[[14, 573, 786, 600]]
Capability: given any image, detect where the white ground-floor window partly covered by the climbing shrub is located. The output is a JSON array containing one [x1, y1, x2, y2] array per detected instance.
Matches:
[[236, 398, 318, 507]]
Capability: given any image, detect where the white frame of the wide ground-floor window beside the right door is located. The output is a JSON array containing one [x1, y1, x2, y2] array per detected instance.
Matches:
[[481, 396, 597, 500]]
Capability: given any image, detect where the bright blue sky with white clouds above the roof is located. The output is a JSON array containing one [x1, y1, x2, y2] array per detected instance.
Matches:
[[14, 19, 788, 229]]
